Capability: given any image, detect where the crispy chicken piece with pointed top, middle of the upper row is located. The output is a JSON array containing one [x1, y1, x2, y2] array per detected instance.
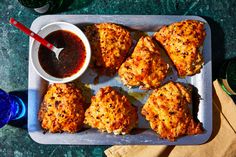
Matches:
[[118, 36, 168, 89]]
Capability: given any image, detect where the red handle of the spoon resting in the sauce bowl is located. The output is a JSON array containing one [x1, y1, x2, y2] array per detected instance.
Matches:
[[9, 18, 54, 50]]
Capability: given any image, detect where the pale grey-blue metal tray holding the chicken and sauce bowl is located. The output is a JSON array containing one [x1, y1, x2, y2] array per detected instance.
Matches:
[[28, 15, 212, 145]]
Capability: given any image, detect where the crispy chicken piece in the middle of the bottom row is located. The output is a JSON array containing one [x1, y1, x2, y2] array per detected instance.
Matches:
[[84, 86, 138, 135]]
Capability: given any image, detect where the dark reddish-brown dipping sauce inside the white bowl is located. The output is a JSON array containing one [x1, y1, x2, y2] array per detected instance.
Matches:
[[38, 30, 86, 78]]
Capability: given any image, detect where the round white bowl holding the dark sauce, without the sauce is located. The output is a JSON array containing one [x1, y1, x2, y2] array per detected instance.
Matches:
[[30, 22, 91, 83]]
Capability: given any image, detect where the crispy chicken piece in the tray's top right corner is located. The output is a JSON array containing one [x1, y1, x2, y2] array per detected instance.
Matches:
[[154, 20, 206, 76]]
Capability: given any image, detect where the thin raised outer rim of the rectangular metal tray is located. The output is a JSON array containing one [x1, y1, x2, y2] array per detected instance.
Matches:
[[28, 14, 213, 145]]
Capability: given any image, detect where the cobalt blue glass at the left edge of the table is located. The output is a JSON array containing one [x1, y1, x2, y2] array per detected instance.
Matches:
[[0, 89, 26, 128]]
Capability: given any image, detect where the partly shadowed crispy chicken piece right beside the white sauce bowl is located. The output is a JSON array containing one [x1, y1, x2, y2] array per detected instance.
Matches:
[[85, 23, 132, 75]]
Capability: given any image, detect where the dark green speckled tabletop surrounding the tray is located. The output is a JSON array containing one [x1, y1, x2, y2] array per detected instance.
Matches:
[[0, 0, 236, 157]]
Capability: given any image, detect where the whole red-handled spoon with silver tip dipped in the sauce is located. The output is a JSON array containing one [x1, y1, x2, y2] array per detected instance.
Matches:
[[9, 18, 64, 60]]
